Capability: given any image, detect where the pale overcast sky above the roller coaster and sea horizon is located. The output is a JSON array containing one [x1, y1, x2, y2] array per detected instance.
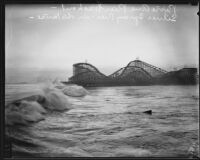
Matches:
[[6, 5, 199, 82]]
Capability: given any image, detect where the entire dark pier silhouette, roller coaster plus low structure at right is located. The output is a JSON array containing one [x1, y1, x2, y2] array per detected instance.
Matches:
[[66, 60, 198, 87]]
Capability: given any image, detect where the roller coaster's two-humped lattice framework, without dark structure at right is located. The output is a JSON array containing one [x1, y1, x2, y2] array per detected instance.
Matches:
[[69, 60, 167, 86]]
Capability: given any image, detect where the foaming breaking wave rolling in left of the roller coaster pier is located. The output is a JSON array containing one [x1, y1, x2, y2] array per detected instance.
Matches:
[[5, 82, 88, 125]]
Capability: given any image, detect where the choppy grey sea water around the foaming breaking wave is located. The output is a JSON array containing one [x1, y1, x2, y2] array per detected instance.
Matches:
[[6, 84, 199, 157]]
